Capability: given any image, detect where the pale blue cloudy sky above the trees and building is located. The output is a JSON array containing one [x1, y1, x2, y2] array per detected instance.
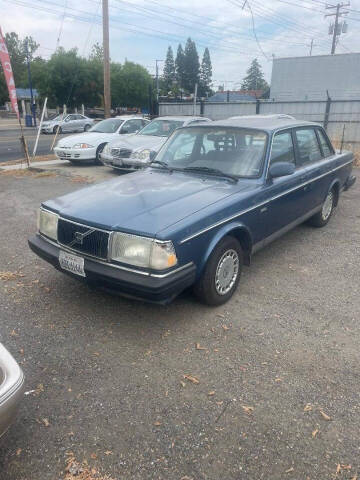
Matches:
[[0, 0, 360, 89]]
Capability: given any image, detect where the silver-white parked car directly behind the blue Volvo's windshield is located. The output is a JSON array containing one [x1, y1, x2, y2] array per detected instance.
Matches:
[[100, 116, 211, 171]]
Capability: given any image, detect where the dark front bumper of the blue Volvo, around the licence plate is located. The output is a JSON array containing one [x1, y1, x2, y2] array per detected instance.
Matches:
[[29, 234, 196, 303]]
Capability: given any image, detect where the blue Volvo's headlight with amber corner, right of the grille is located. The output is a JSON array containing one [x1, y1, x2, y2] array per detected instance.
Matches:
[[110, 232, 177, 270]]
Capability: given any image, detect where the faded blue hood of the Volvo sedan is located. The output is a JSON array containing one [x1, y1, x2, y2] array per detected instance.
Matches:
[[43, 168, 254, 236]]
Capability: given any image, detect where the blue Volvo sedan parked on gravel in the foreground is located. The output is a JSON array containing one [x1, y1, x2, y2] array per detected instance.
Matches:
[[29, 116, 355, 305]]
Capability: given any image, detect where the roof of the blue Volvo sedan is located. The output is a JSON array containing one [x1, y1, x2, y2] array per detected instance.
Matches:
[[181, 115, 319, 132]]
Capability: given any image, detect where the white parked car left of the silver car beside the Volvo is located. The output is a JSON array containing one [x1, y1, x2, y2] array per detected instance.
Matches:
[[54, 115, 150, 163]]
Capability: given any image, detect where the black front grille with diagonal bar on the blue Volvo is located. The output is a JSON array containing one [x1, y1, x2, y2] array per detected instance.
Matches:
[[58, 218, 110, 259]]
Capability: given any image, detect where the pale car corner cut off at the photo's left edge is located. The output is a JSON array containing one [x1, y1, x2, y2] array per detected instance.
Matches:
[[0, 344, 24, 437]]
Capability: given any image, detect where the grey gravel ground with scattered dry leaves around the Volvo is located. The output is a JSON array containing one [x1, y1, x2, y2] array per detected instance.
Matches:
[[0, 166, 360, 480]]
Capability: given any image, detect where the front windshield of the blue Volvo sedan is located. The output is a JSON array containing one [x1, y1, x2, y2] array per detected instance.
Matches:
[[154, 127, 267, 177]]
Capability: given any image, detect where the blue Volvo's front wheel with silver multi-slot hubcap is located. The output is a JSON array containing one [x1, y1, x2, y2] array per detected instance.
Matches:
[[194, 236, 243, 306]]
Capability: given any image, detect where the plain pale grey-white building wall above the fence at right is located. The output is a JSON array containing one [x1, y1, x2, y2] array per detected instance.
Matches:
[[270, 53, 360, 101]]
